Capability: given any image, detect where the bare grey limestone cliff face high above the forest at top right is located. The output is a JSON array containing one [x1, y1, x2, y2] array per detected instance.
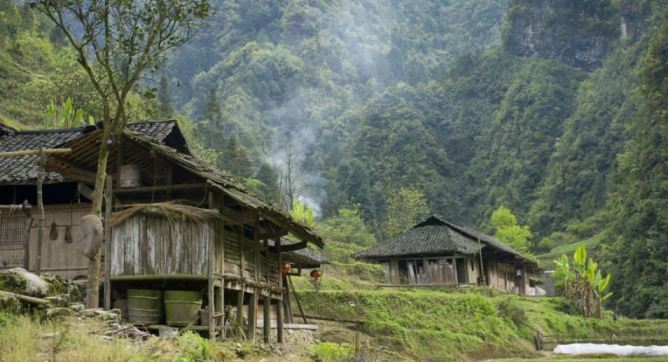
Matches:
[[502, 0, 629, 70]]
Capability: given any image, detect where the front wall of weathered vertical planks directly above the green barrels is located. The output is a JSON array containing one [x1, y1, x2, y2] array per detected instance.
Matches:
[[111, 214, 212, 276]]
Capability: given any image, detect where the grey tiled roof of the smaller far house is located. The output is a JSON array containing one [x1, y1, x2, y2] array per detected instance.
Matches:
[[355, 216, 533, 263]]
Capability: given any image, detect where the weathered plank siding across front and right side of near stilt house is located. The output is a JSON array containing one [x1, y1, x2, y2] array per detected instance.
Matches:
[[111, 214, 280, 287]]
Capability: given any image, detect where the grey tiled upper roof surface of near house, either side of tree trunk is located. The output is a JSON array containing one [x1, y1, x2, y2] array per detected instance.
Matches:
[[0, 120, 185, 185]]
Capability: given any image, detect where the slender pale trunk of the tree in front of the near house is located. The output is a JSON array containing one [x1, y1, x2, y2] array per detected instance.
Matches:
[[86, 133, 111, 308]]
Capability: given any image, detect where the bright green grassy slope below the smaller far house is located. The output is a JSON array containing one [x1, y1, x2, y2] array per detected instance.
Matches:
[[295, 277, 668, 360]]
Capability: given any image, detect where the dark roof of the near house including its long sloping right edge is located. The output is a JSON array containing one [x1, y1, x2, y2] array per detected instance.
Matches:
[[13, 121, 324, 247]]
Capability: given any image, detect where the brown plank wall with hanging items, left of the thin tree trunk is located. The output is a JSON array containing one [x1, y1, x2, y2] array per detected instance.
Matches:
[[0, 203, 91, 279]]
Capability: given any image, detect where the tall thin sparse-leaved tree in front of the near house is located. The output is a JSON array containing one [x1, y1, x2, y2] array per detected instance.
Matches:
[[31, 0, 211, 307]]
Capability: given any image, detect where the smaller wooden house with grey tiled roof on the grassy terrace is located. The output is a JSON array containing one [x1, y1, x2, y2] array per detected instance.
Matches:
[[356, 216, 538, 295]]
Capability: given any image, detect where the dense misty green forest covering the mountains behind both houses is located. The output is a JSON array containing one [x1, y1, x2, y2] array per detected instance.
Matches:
[[0, 0, 668, 317]]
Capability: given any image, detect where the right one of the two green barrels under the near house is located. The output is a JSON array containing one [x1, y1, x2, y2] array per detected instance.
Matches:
[[165, 290, 202, 327]]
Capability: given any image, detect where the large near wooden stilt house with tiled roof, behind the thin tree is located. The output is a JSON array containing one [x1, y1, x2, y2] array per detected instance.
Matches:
[[0, 121, 323, 341]]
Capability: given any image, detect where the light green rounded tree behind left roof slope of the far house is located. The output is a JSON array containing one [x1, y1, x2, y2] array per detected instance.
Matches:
[[383, 187, 429, 237]]
